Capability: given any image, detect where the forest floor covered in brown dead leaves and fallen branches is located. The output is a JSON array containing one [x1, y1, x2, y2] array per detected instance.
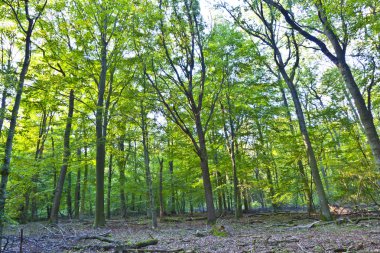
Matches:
[[3, 213, 380, 253]]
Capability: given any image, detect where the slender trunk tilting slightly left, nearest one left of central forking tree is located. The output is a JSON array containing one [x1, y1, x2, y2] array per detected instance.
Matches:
[[141, 102, 157, 229]]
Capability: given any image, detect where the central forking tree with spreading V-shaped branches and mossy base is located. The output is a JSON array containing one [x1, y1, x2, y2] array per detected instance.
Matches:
[[145, 0, 220, 223]]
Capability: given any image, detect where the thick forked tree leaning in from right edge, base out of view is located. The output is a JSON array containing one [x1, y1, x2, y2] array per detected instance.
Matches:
[[264, 0, 380, 169]]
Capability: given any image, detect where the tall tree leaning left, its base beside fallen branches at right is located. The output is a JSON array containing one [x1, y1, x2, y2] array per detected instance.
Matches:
[[226, 1, 332, 220]]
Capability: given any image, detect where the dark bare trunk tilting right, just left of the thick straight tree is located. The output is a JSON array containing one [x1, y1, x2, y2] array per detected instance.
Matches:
[[50, 90, 74, 223]]
